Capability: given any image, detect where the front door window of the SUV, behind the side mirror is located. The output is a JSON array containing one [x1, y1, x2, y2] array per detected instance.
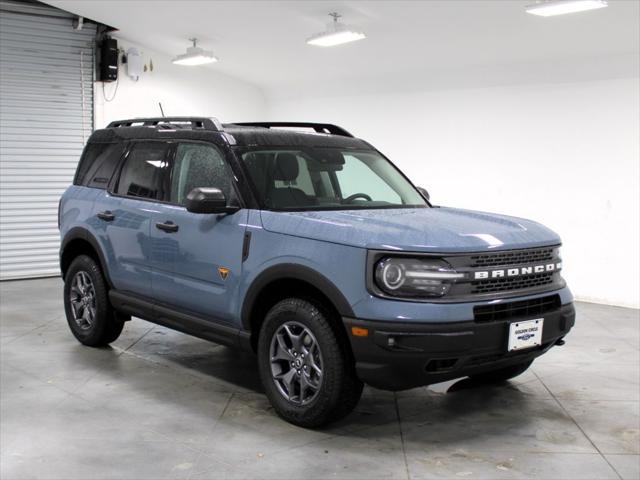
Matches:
[[171, 143, 233, 205]]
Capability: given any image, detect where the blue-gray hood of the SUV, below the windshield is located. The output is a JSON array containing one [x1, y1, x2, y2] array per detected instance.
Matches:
[[262, 207, 560, 253]]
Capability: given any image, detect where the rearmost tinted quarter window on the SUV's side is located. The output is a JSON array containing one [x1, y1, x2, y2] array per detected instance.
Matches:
[[73, 143, 124, 189]]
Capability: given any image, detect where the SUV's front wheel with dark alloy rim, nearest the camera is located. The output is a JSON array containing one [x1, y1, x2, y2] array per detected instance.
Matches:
[[258, 298, 363, 427]]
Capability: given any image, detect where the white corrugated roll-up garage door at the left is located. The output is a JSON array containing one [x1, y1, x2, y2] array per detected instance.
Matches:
[[0, 0, 96, 280]]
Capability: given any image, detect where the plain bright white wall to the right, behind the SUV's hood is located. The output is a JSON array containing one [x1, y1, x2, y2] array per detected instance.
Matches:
[[269, 78, 640, 308]]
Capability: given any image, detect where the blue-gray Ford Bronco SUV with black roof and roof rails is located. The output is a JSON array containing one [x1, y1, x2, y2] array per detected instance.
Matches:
[[59, 117, 575, 427]]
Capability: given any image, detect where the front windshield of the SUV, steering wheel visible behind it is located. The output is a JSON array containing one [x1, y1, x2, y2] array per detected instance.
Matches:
[[240, 147, 427, 210]]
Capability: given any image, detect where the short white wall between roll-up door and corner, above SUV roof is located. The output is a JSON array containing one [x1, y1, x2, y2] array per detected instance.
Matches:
[[95, 40, 266, 128]]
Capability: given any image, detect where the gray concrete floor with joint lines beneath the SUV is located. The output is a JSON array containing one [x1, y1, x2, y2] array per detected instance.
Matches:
[[0, 279, 640, 479]]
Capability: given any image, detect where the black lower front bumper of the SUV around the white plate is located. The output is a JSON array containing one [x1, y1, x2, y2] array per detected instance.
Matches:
[[343, 303, 575, 390]]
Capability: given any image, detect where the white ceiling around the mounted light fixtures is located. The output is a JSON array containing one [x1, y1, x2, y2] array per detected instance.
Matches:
[[46, 0, 640, 96]]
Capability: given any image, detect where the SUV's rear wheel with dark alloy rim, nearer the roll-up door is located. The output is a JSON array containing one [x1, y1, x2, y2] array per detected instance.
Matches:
[[64, 255, 124, 347]]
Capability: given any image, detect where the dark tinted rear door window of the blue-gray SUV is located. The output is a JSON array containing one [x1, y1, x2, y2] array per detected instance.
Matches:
[[116, 142, 169, 200]]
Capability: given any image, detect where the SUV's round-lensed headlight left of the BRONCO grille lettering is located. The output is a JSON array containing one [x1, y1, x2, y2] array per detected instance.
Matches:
[[375, 257, 465, 297]]
